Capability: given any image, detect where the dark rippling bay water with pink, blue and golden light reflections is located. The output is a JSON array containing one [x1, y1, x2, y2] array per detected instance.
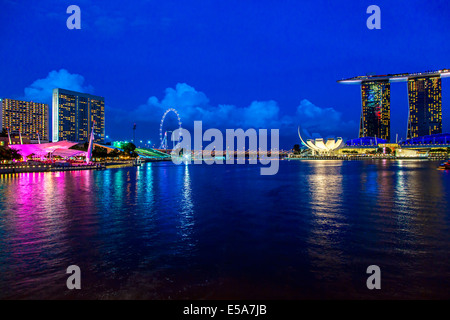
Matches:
[[0, 160, 450, 299]]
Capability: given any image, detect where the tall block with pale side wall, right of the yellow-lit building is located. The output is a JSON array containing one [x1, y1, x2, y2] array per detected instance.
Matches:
[[52, 88, 105, 143]]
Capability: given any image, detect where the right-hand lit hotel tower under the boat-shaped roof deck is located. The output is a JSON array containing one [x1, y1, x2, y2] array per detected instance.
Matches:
[[407, 76, 442, 139]]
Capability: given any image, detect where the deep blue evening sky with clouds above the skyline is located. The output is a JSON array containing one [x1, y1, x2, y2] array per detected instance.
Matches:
[[0, 0, 450, 148]]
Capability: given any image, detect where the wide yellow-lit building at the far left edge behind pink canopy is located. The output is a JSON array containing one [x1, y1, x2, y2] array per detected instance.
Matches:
[[0, 99, 49, 142]]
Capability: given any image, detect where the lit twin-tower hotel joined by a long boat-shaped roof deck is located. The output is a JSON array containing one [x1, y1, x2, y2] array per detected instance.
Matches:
[[338, 69, 450, 141]]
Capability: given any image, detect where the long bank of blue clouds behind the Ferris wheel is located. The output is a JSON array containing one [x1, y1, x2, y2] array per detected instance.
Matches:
[[116, 83, 357, 137]]
